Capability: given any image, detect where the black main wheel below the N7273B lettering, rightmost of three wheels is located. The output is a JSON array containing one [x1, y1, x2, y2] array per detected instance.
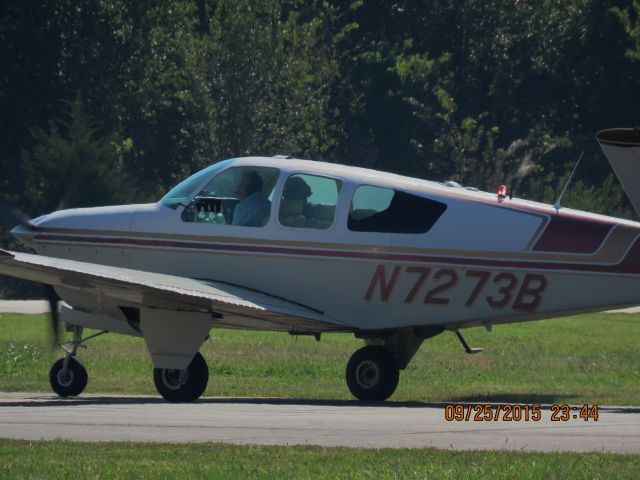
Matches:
[[346, 345, 400, 401]]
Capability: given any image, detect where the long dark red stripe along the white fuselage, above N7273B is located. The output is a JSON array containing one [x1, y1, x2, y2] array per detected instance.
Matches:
[[35, 234, 640, 274]]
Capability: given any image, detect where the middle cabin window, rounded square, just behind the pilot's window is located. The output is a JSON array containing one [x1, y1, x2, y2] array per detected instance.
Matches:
[[278, 174, 342, 230]]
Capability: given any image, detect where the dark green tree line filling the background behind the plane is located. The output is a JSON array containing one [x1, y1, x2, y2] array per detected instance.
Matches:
[[0, 0, 640, 294]]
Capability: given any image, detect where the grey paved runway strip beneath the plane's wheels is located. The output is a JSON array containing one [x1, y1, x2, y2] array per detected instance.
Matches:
[[0, 392, 640, 453]]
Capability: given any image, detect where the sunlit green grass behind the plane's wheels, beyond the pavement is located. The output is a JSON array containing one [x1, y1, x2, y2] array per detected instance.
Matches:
[[0, 313, 640, 405]]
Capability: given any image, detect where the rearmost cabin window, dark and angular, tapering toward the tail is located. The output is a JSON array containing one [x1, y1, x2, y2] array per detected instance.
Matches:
[[347, 185, 447, 233]]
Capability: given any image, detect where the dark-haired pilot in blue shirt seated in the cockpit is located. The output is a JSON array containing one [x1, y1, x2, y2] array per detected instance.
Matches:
[[231, 170, 271, 227]]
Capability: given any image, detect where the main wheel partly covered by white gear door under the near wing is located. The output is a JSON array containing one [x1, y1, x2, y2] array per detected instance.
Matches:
[[153, 352, 209, 402]]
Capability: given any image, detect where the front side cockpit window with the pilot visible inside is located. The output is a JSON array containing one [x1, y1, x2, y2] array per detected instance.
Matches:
[[182, 167, 280, 227]]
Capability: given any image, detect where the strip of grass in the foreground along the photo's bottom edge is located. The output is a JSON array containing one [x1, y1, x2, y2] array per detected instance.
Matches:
[[0, 440, 640, 480]]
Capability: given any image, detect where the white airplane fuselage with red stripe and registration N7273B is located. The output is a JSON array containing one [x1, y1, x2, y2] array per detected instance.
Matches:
[[17, 158, 640, 330]]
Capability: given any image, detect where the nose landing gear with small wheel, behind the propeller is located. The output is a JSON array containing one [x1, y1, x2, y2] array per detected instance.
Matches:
[[49, 325, 107, 397]]
